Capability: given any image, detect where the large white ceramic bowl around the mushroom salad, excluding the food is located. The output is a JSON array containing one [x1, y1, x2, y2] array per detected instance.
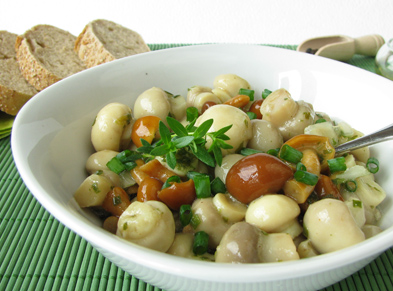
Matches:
[[12, 45, 393, 291]]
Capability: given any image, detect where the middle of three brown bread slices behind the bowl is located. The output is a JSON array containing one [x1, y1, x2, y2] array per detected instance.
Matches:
[[15, 25, 86, 90]]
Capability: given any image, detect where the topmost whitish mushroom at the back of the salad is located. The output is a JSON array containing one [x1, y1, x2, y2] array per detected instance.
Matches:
[[212, 74, 251, 103]]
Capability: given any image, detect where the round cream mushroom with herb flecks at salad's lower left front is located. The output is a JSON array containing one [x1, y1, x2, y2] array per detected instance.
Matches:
[[117, 200, 175, 252]]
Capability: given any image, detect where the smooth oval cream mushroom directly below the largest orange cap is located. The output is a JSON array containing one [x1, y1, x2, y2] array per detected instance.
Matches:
[[246, 194, 300, 233]]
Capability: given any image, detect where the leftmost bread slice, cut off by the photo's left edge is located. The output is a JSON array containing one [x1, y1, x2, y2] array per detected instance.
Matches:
[[0, 30, 37, 115]]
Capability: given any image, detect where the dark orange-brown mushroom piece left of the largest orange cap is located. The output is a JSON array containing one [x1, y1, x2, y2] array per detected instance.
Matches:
[[158, 179, 196, 210]]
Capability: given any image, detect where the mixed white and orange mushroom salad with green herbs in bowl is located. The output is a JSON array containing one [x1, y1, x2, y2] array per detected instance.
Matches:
[[74, 74, 386, 263]]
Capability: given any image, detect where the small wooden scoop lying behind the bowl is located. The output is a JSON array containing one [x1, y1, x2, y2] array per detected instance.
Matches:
[[297, 34, 385, 61]]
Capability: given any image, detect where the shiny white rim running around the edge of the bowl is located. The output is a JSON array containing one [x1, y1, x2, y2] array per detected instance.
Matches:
[[11, 44, 393, 282]]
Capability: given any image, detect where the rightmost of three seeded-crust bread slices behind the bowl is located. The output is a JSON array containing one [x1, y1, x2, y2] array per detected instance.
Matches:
[[75, 19, 150, 68]]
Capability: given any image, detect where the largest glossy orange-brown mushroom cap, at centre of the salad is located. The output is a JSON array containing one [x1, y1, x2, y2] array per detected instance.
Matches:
[[226, 153, 293, 204]]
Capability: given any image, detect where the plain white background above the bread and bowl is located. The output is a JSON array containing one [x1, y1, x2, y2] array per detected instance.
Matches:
[[0, 0, 393, 44]]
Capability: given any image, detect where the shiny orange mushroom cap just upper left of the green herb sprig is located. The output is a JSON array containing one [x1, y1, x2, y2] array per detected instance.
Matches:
[[131, 116, 161, 148]]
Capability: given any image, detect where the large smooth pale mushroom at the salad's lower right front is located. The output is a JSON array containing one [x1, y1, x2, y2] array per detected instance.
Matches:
[[303, 198, 365, 254]]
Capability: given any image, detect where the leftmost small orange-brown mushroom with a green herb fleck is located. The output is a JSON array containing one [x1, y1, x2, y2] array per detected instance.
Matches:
[[102, 187, 131, 217]]
